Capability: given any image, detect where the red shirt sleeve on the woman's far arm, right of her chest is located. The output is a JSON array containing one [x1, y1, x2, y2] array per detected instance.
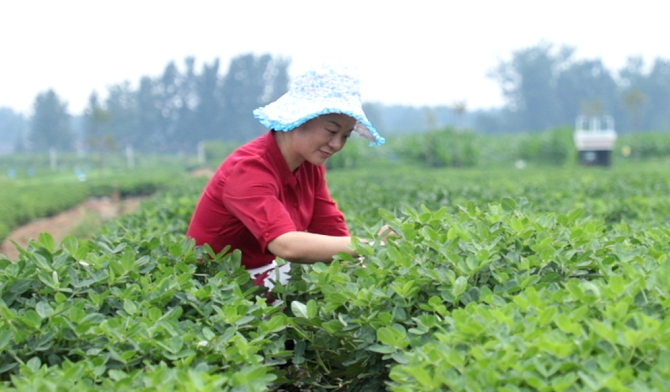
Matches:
[[307, 166, 349, 236]]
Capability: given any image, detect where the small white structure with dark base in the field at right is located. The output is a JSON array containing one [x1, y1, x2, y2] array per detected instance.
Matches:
[[574, 116, 617, 166]]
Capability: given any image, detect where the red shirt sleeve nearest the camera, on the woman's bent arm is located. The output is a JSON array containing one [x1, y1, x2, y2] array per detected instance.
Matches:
[[221, 159, 296, 252]]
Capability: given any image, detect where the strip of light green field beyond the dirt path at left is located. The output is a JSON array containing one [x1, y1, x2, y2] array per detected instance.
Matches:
[[0, 155, 194, 241]]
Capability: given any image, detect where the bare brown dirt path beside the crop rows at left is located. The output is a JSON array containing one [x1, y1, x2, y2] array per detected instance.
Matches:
[[0, 197, 146, 260]]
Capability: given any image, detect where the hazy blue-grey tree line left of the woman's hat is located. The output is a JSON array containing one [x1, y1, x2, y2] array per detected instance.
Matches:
[[0, 54, 290, 152]]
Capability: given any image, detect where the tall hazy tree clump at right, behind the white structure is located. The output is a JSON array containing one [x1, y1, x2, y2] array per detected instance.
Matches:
[[478, 42, 670, 132]]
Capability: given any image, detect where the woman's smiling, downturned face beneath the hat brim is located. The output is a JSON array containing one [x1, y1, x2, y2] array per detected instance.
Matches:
[[289, 113, 356, 167]]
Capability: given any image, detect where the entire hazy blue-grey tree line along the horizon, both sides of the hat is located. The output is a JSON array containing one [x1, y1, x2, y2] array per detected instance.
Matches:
[[0, 42, 670, 152]]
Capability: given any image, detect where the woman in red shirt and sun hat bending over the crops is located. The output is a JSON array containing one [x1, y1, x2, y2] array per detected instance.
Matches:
[[187, 64, 385, 289]]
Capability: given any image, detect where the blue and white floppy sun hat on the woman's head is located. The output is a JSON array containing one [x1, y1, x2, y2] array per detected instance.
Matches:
[[254, 63, 386, 146]]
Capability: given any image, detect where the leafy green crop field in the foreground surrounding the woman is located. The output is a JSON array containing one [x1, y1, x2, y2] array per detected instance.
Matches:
[[0, 130, 670, 392]]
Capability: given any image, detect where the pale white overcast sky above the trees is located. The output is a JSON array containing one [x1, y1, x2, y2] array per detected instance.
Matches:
[[0, 0, 670, 115]]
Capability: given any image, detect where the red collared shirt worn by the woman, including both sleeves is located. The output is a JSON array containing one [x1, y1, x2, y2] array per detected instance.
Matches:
[[187, 131, 349, 268]]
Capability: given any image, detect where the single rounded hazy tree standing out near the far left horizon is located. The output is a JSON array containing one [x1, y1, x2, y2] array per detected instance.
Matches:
[[30, 90, 73, 152]]
